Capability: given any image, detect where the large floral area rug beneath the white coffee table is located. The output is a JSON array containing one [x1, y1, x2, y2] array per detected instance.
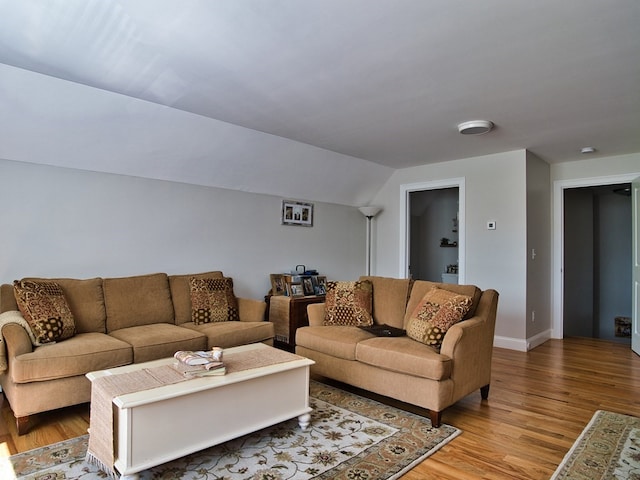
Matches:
[[0, 382, 461, 480]]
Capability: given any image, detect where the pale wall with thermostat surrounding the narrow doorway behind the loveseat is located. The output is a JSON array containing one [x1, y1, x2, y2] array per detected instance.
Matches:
[[372, 150, 527, 339]]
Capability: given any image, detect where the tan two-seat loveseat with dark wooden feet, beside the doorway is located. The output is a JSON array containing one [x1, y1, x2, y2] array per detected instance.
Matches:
[[296, 277, 498, 427]]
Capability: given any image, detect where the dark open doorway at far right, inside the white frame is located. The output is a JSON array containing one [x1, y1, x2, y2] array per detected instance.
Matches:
[[563, 183, 632, 344]]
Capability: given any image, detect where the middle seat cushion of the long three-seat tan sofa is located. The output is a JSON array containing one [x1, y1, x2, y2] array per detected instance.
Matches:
[[109, 323, 207, 363]]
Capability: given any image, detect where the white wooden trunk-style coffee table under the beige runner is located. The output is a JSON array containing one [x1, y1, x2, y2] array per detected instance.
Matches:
[[87, 343, 314, 479]]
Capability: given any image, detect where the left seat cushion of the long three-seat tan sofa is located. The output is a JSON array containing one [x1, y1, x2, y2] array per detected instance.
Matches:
[[10, 332, 133, 383]]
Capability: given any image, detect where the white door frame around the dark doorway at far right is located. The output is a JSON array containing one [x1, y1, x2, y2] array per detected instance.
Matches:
[[551, 173, 640, 338]]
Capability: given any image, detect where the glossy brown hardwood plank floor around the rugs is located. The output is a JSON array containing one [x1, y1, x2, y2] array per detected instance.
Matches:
[[0, 338, 640, 480]]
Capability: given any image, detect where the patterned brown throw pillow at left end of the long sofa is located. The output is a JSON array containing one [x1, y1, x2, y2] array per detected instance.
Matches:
[[13, 280, 75, 343]]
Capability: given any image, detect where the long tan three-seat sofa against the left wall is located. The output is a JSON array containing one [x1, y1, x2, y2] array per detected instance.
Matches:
[[0, 271, 274, 434]]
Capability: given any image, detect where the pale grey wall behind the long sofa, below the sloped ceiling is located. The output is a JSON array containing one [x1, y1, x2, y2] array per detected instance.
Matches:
[[0, 160, 366, 298]]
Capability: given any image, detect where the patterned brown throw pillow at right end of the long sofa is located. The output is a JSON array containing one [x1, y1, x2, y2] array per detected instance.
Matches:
[[189, 277, 240, 325]]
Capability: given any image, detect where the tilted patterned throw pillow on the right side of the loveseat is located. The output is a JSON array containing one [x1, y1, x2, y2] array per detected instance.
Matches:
[[407, 287, 472, 349]]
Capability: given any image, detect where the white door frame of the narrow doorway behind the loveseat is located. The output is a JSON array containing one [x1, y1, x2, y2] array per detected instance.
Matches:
[[398, 177, 465, 284]]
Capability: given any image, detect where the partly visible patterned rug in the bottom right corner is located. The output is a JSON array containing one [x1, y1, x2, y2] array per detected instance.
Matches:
[[551, 410, 640, 480]]
